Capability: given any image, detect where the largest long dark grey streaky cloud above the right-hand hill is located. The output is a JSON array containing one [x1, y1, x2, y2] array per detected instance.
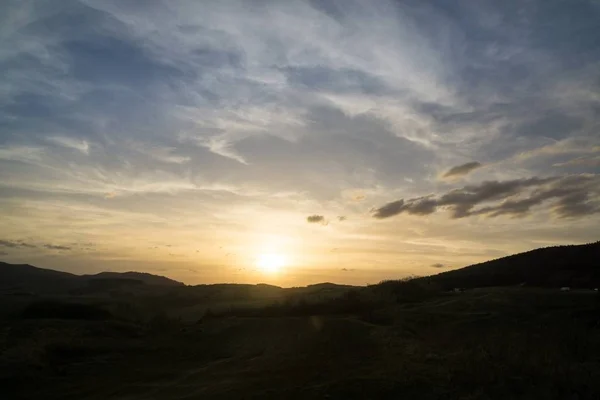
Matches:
[[373, 175, 600, 219]]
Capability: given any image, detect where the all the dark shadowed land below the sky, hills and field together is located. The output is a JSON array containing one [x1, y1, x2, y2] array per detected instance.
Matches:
[[0, 242, 600, 400]]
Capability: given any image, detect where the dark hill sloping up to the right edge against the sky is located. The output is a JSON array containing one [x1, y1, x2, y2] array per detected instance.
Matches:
[[420, 242, 600, 289]]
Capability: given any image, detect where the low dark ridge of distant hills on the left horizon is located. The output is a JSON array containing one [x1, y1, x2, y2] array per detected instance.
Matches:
[[0, 262, 185, 293]]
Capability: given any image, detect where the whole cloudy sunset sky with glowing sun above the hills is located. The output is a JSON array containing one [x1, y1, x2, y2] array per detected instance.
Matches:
[[0, 0, 600, 286]]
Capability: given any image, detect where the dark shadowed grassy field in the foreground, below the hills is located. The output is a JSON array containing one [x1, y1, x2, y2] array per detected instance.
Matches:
[[0, 288, 600, 400]]
